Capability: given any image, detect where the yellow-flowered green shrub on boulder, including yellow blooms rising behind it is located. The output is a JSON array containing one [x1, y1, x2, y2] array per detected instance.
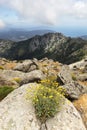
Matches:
[[27, 76, 65, 123]]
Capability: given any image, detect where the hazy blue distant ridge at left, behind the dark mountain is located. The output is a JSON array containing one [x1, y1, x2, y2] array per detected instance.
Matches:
[[0, 29, 53, 41]]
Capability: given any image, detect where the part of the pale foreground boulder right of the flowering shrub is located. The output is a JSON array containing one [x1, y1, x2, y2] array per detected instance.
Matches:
[[46, 100, 86, 130]]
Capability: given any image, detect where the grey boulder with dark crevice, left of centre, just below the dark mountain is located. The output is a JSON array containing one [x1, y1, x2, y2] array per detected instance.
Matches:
[[14, 59, 38, 72]]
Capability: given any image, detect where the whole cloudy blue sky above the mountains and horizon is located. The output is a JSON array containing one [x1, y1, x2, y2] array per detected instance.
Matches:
[[0, 0, 87, 36]]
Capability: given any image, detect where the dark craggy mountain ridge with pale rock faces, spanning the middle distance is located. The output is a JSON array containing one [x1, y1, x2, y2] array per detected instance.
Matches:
[[0, 33, 87, 64]]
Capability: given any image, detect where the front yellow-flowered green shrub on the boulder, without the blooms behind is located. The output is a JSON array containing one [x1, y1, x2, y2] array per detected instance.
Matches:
[[28, 84, 63, 123]]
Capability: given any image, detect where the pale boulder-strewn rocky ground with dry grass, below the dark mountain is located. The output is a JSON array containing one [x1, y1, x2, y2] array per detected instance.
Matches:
[[0, 58, 87, 130]]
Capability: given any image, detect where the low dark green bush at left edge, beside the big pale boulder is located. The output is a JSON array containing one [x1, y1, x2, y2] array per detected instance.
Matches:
[[0, 86, 14, 100]]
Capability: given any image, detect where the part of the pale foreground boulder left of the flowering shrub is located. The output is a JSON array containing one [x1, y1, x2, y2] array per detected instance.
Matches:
[[0, 84, 40, 130]]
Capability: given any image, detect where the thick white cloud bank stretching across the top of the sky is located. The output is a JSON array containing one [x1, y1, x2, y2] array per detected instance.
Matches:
[[0, 0, 87, 25]]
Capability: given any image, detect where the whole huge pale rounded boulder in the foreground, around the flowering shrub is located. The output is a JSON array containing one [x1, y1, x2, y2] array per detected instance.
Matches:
[[0, 83, 86, 130]]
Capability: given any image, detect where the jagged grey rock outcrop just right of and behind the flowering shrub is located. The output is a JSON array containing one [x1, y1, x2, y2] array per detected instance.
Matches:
[[58, 65, 87, 100]]
